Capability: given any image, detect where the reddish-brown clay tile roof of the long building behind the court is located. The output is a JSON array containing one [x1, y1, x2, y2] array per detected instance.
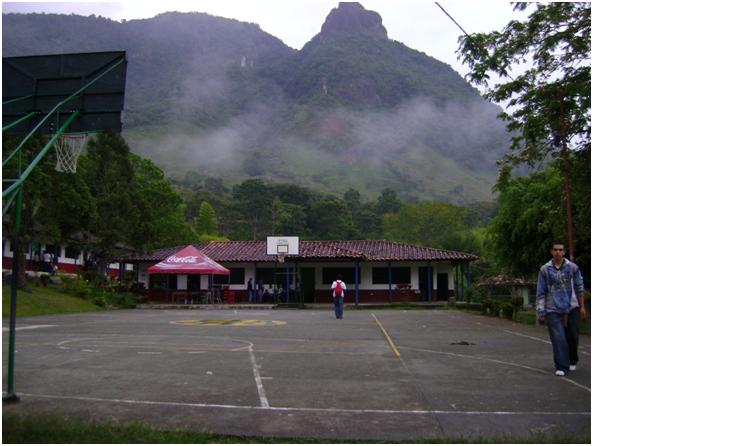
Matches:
[[123, 240, 478, 263]]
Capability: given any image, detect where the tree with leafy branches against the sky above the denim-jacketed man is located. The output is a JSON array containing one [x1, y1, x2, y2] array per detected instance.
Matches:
[[460, 3, 592, 258]]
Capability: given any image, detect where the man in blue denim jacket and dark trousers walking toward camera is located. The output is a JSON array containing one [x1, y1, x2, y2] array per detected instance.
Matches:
[[536, 243, 587, 376]]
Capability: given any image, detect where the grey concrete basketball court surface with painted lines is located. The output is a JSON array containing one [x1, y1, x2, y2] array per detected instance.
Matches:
[[3, 306, 591, 442]]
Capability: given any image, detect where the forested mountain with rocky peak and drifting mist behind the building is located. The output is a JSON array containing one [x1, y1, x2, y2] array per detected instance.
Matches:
[[3, 3, 509, 203]]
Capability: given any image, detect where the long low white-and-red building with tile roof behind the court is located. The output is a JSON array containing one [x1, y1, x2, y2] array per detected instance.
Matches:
[[123, 240, 478, 304]]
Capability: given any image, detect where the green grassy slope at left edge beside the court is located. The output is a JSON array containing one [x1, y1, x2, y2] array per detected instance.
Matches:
[[3, 284, 104, 319]]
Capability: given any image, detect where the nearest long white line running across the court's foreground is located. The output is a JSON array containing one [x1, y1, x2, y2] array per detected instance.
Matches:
[[18, 393, 592, 416]]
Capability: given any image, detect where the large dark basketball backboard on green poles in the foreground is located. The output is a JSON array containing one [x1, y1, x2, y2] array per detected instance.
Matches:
[[3, 51, 127, 134]]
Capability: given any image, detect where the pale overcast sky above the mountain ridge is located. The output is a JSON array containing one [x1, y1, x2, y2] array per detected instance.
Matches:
[[3, 0, 524, 75]]
